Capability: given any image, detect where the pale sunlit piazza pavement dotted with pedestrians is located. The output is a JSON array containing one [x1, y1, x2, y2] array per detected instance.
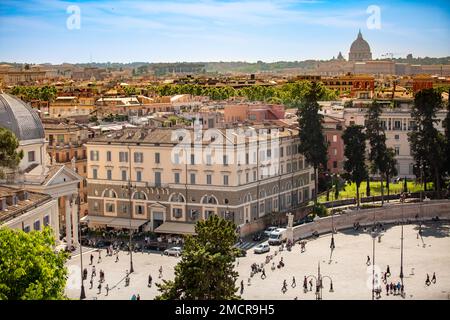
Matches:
[[66, 222, 450, 300]]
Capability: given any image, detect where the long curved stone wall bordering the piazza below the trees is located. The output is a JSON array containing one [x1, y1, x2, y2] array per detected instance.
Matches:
[[293, 200, 450, 240]]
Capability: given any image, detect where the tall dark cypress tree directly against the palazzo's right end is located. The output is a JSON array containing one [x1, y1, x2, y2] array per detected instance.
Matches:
[[297, 82, 328, 205]]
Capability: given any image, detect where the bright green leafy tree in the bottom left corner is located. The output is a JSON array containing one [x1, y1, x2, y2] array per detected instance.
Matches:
[[0, 227, 69, 300]]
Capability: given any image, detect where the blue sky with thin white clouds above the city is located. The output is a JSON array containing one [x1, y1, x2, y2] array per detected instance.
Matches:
[[0, 0, 450, 63]]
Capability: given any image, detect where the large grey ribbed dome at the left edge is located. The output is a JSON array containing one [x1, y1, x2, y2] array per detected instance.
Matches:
[[0, 94, 45, 141]]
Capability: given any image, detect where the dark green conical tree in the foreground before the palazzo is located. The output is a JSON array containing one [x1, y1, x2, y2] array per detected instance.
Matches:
[[156, 215, 239, 300]]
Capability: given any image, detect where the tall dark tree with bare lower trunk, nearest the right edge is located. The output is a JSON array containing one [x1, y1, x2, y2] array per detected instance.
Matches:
[[408, 89, 446, 198]]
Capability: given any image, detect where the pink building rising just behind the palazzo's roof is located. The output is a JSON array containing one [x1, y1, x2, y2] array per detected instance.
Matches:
[[224, 103, 284, 123]]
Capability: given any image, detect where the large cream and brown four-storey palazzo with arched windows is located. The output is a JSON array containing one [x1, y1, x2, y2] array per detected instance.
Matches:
[[83, 125, 314, 234]]
